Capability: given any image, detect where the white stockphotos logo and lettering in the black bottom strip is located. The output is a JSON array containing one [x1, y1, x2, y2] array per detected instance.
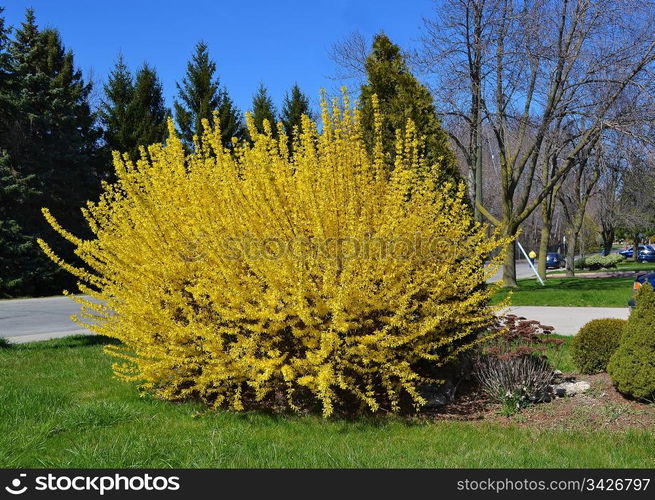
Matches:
[[5, 472, 180, 496]]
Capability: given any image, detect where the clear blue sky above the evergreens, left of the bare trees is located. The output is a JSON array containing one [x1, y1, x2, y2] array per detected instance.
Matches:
[[0, 0, 434, 111]]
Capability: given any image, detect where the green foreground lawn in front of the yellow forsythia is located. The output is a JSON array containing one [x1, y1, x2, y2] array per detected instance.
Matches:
[[0, 337, 655, 468]]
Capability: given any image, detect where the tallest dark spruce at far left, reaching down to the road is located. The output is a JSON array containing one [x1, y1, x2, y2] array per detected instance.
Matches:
[[0, 9, 100, 295]]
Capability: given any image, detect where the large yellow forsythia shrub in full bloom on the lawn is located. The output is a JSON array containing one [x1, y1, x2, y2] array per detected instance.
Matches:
[[40, 96, 507, 416]]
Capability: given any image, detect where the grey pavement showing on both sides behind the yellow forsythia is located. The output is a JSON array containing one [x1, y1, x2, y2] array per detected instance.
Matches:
[[0, 297, 630, 343]]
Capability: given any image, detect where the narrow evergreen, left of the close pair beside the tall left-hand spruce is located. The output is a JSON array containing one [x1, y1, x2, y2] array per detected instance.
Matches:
[[99, 54, 134, 158]]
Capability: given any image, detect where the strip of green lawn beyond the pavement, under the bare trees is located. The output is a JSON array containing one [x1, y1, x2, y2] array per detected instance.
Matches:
[[492, 277, 634, 307]]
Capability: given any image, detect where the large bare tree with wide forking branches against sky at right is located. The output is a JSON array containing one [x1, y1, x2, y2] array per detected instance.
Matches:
[[426, 0, 655, 286]]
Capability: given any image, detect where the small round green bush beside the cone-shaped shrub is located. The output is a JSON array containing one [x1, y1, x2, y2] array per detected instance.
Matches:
[[571, 318, 626, 373]]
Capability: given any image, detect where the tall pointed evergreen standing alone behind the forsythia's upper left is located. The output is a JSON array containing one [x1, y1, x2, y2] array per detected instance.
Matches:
[[174, 42, 244, 145]]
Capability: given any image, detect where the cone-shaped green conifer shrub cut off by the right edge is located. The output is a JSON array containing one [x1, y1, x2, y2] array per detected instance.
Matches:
[[607, 283, 655, 401]]
